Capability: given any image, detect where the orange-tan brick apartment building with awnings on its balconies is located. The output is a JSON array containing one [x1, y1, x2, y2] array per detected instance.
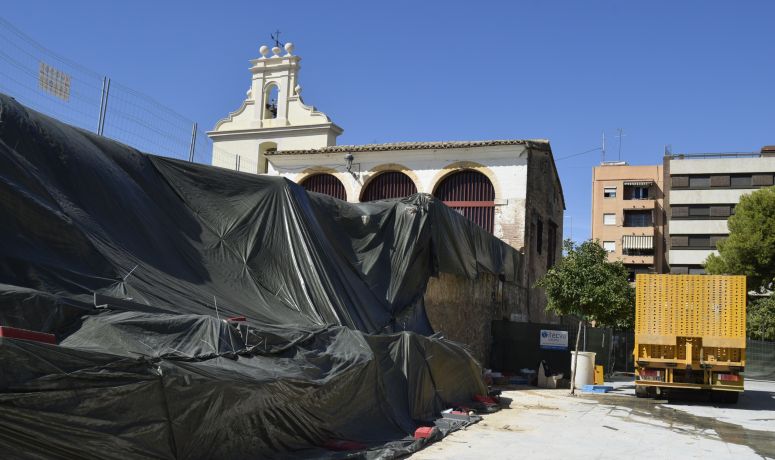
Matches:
[[592, 162, 665, 281]]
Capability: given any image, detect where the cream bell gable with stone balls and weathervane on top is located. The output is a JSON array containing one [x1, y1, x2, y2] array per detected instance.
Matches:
[[207, 43, 342, 174]]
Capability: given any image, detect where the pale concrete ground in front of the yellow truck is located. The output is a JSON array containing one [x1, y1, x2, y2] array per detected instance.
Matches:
[[411, 380, 775, 460]]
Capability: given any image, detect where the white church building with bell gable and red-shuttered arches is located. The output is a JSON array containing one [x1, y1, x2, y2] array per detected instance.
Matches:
[[207, 43, 565, 356]]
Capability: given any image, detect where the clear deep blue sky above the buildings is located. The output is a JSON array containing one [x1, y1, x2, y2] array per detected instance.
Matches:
[[0, 0, 775, 240]]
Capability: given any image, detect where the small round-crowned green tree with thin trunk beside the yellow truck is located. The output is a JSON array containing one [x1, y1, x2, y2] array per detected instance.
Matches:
[[536, 240, 635, 394]]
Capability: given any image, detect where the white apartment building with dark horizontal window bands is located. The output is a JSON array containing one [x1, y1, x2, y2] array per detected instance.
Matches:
[[663, 146, 775, 274]]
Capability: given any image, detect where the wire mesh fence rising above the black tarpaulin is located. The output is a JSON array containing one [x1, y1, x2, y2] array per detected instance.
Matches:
[[0, 18, 236, 172]]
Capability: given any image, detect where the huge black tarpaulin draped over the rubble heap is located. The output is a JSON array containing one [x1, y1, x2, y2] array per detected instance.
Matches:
[[0, 95, 520, 459]]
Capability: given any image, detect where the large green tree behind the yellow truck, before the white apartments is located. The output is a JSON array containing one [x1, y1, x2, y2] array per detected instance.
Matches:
[[705, 187, 775, 289]]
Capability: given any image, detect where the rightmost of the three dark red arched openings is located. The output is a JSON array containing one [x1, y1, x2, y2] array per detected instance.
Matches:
[[433, 169, 495, 233]]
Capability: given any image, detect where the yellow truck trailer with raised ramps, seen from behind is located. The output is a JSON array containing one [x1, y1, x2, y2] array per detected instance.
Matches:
[[634, 275, 746, 403]]
